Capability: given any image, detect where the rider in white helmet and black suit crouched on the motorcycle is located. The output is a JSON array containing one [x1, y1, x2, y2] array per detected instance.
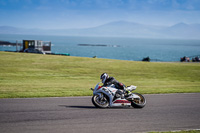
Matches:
[[100, 73, 129, 93]]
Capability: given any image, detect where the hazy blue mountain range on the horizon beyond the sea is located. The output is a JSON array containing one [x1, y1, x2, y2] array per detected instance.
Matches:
[[0, 21, 200, 39]]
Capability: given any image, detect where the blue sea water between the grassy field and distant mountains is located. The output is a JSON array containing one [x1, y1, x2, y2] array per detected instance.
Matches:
[[0, 34, 200, 61]]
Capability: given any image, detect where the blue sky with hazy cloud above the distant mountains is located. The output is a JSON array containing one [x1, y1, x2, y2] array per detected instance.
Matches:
[[0, 0, 200, 29]]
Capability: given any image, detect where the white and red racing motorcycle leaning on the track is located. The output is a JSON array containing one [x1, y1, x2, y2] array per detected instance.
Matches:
[[91, 82, 146, 108]]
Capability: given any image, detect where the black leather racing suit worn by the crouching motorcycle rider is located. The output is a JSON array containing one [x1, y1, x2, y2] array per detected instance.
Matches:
[[103, 77, 125, 90]]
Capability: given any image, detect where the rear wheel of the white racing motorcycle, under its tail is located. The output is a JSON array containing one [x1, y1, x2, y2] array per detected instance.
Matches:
[[131, 93, 146, 108]]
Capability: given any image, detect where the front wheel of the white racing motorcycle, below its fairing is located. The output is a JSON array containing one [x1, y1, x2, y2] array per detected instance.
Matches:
[[92, 95, 109, 108]]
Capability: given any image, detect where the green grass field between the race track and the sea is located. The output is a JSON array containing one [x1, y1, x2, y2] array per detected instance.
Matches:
[[0, 52, 200, 98]]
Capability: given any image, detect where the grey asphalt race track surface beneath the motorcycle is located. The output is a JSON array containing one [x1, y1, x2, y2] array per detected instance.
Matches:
[[0, 93, 200, 133]]
